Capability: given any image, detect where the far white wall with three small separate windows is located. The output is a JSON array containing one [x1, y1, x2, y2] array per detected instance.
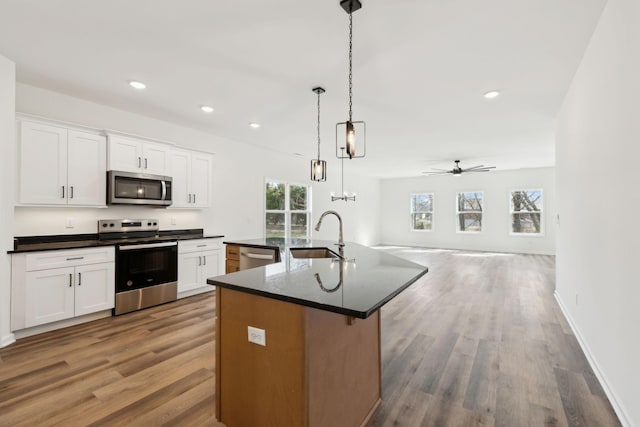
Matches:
[[381, 168, 556, 254]]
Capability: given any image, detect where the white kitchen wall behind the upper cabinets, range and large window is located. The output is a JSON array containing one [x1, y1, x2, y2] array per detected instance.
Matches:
[[13, 84, 379, 244]]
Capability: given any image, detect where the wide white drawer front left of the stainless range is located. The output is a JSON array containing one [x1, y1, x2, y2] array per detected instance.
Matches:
[[25, 246, 115, 271]]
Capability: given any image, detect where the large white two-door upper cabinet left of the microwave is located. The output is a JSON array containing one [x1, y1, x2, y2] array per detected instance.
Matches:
[[18, 120, 106, 206]]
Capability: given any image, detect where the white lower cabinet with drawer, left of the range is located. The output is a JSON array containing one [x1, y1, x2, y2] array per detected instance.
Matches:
[[11, 247, 115, 331]]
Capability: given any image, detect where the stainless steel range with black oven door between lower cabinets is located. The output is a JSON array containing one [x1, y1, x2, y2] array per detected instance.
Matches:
[[98, 219, 178, 316]]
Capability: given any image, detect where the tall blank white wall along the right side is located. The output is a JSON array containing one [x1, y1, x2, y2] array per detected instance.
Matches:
[[556, 0, 640, 426]]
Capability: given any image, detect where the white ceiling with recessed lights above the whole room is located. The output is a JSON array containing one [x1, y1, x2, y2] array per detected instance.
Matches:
[[0, 0, 606, 177]]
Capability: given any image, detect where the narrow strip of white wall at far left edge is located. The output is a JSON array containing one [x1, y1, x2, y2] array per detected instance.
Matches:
[[0, 56, 15, 347]]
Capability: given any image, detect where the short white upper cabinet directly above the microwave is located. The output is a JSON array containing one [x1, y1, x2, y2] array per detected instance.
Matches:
[[109, 135, 169, 175]]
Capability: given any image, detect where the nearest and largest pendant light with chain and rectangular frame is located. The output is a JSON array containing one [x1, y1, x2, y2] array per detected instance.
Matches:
[[336, 0, 367, 159]]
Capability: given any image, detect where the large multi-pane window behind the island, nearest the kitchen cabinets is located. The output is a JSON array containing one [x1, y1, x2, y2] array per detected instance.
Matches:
[[265, 180, 311, 238]]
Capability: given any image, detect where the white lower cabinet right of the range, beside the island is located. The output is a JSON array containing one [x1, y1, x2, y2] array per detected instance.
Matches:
[[178, 239, 223, 294]]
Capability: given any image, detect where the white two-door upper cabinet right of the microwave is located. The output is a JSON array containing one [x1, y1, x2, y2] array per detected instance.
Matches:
[[170, 150, 213, 208]]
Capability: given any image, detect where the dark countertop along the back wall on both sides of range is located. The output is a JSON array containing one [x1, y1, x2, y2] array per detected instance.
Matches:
[[7, 228, 224, 254]]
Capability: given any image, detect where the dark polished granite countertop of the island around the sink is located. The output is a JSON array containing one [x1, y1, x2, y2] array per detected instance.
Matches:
[[207, 239, 428, 319]]
